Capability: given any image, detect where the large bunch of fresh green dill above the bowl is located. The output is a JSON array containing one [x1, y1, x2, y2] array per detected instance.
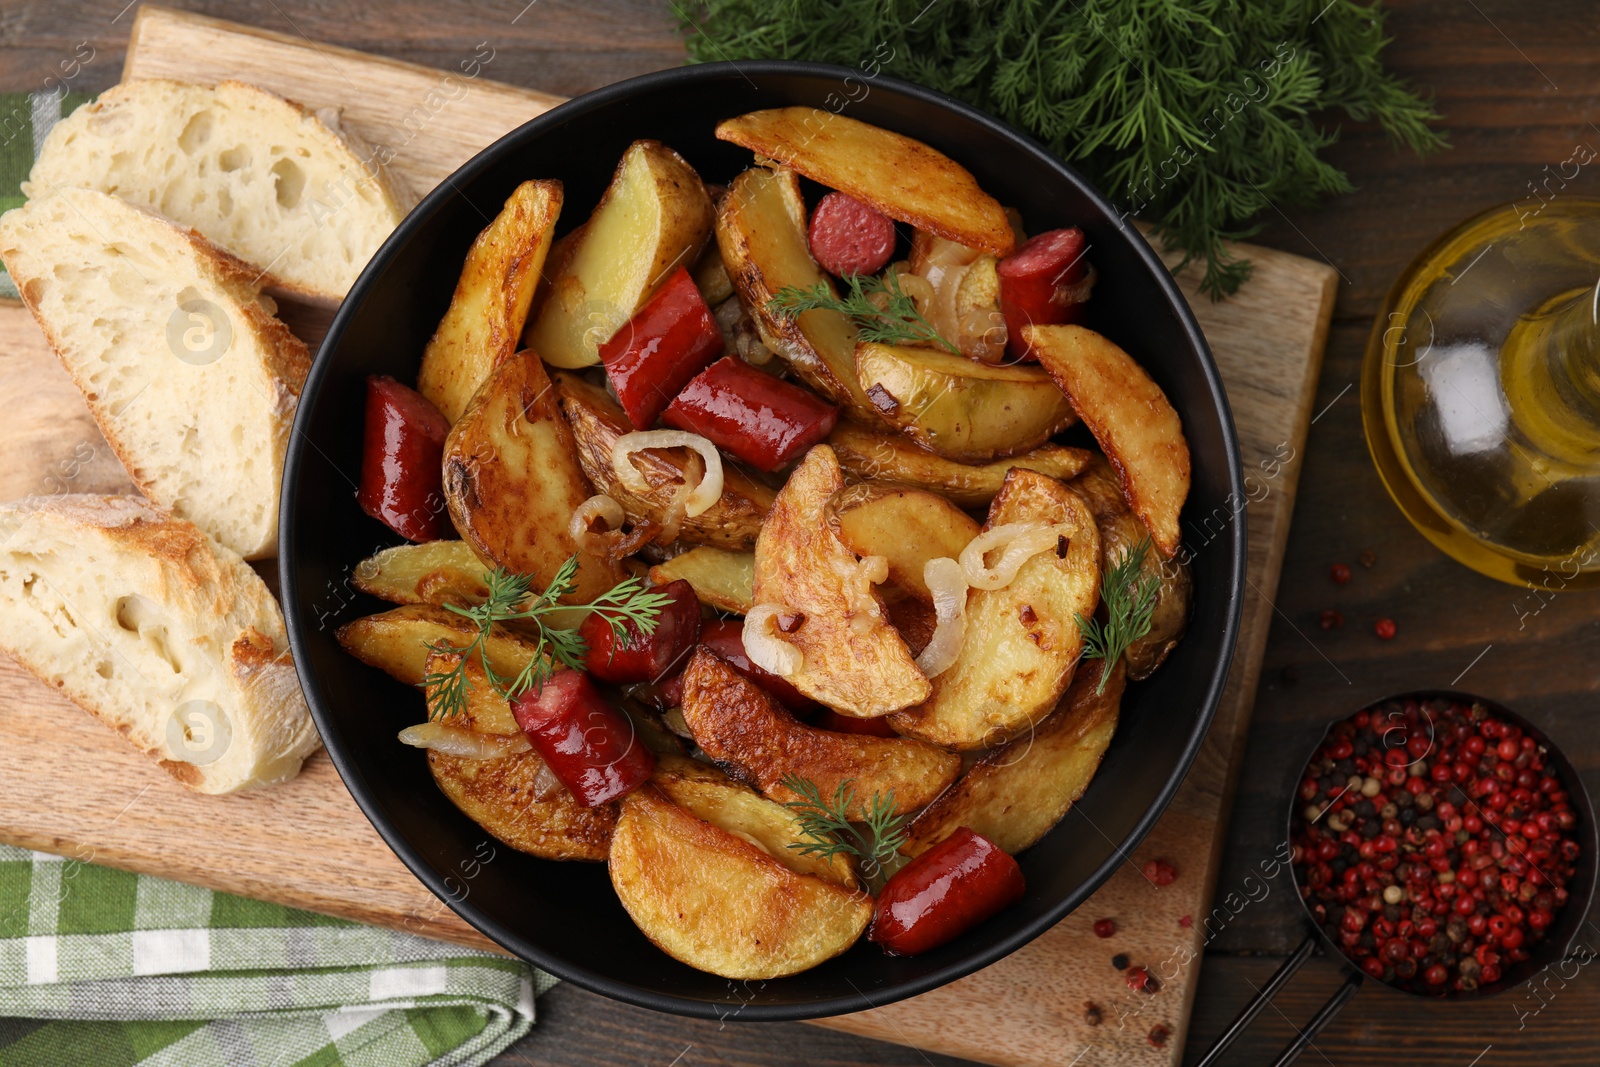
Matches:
[[674, 0, 1445, 299]]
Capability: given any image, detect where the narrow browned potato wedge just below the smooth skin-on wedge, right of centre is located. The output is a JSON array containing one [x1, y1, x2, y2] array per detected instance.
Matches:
[[827, 419, 1090, 507]]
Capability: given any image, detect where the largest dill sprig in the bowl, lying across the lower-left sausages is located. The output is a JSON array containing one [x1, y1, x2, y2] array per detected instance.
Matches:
[[422, 555, 670, 718]]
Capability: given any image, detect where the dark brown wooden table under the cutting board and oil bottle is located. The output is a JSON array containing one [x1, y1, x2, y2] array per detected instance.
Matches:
[[0, 0, 1600, 1067]]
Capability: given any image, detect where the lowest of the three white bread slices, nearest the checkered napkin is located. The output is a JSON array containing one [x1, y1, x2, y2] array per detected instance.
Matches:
[[0, 496, 318, 793]]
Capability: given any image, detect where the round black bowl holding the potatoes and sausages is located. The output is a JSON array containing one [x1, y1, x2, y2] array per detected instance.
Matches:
[[280, 62, 1245, 1019]]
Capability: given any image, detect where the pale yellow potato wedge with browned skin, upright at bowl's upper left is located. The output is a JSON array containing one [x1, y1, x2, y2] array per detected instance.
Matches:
[[523, 141, 712, 368]]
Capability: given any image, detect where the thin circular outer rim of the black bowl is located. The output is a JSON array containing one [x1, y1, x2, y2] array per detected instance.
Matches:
[[278, 59, 1248, 1022]]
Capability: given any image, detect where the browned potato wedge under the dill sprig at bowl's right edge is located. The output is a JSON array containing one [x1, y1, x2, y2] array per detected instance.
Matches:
[[1070, 456, 1194, 681]]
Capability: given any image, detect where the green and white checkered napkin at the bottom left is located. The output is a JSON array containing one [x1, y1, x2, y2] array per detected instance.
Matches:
[[0, 845, 555, 1067]]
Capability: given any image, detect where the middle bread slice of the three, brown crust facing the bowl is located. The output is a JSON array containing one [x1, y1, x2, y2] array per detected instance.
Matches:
[[0, 189, 310, 560]]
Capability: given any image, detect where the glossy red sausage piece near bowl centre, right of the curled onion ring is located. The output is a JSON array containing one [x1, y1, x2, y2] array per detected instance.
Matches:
[[662, 355, 838, 470]]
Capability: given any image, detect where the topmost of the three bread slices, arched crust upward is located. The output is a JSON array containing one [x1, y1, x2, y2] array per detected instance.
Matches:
[[22, 78, 411, 301]]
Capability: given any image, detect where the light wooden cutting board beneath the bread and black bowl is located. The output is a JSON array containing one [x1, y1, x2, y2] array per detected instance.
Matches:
[[0, 6, 1336, 1067]]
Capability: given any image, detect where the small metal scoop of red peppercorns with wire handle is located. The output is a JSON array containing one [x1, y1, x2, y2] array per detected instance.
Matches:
[[1197, 689, 1600, 1067]]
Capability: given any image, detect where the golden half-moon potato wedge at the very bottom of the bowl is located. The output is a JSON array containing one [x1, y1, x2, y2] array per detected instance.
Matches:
[[610, 785, 872, 979]]
